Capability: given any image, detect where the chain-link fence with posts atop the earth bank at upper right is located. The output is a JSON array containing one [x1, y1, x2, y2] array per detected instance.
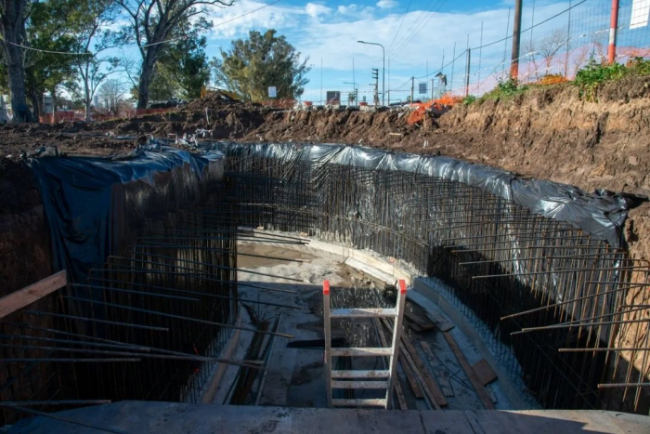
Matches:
[[304, 0, 650, 104]]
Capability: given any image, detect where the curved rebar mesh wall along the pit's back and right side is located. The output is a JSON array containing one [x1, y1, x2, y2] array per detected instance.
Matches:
[[219, 155, 650, 413]]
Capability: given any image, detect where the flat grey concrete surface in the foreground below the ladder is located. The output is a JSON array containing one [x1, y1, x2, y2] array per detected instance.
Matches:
[[8, 401, 650, 434]]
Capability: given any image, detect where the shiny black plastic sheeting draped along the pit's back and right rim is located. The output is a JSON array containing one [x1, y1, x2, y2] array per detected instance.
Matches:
[[201, 142, 647, 247]]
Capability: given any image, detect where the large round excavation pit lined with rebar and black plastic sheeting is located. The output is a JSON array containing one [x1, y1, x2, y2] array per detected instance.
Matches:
[[0, 142, 650, 433]]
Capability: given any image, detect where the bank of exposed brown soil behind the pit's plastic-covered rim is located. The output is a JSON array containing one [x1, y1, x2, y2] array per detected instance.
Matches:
[[0, 77, 650, 257]]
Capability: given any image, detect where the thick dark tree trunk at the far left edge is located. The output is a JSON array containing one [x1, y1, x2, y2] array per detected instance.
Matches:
[[0, 0, 32, 122]]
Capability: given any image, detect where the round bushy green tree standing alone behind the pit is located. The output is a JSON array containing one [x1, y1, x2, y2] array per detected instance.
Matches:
[[211, 30, 310, 101]]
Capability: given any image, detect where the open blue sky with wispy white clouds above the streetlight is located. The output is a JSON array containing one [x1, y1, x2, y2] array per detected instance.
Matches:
[[110, 0, 632, 101]]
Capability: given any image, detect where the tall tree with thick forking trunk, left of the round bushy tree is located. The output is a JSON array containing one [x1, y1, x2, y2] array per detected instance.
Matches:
[[115, 0, 235, 108]]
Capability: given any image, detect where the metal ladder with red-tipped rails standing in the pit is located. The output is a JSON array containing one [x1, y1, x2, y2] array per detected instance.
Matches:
[[323, 280, 406, 408]]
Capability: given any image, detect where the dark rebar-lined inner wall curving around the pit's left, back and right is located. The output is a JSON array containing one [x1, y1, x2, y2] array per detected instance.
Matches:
[[2, 142, 650, 421]]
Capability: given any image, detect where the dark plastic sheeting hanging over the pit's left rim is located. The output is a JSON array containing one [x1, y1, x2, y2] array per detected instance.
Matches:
[[28, 145, 223, 282]]
